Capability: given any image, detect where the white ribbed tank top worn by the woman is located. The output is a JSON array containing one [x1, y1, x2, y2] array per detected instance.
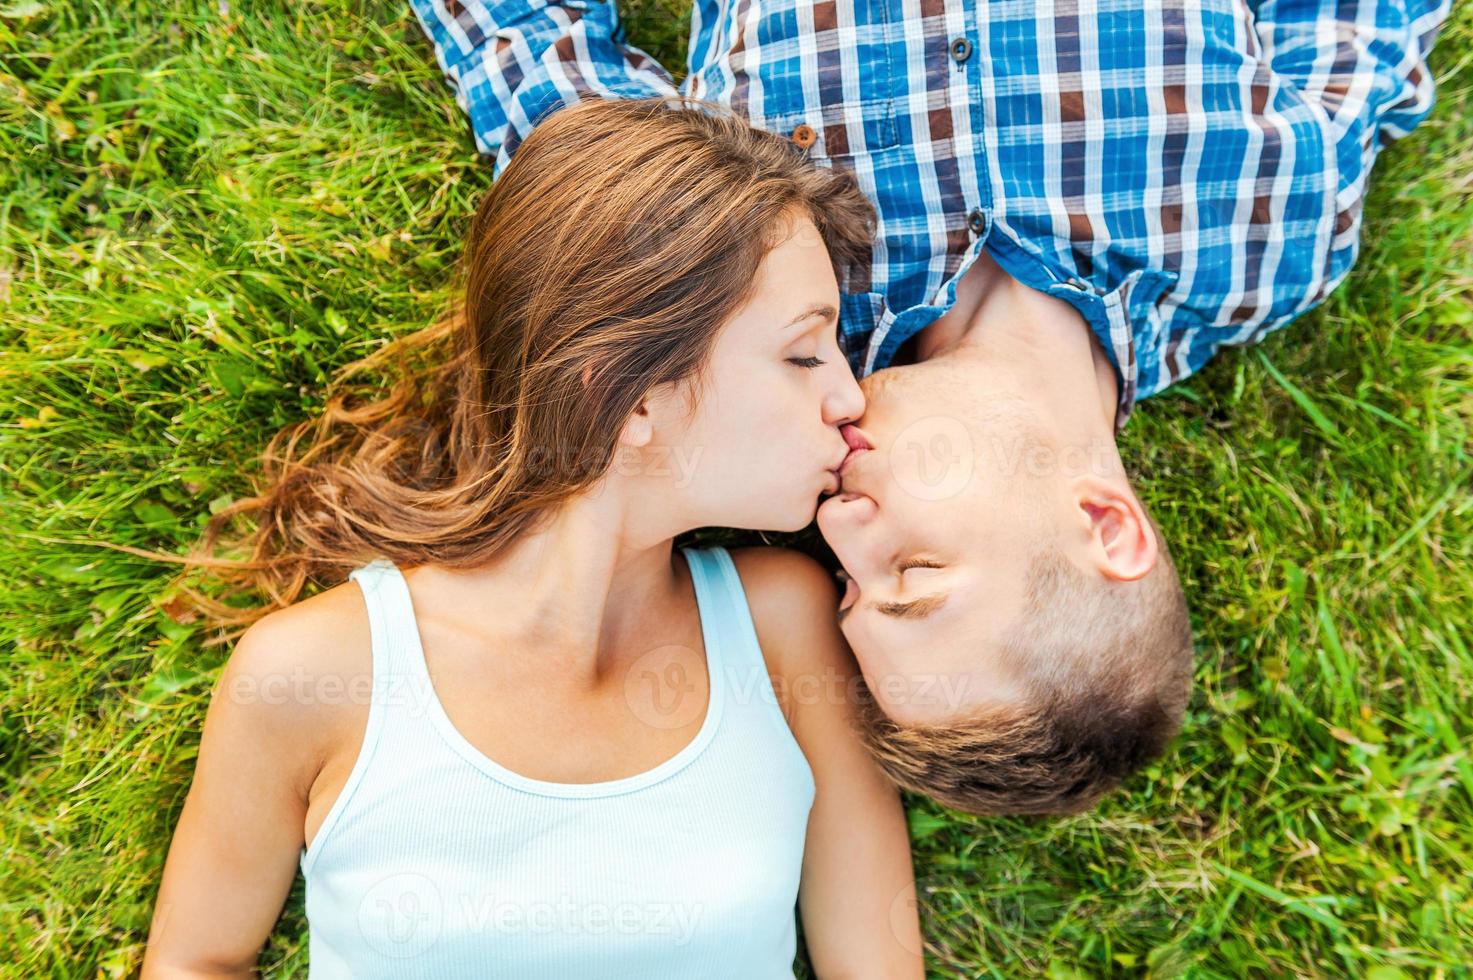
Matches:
[[300, 547, 815, 980]]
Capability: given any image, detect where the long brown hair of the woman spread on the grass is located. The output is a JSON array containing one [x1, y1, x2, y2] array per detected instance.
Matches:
[[164, 96, 873, 644]]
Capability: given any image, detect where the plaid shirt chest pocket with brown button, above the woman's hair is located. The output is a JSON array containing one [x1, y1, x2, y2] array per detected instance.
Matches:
[[725, 0, 906, 158]]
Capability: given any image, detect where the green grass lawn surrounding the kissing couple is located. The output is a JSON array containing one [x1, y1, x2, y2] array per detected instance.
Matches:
[[0, 0, 1473, 979]]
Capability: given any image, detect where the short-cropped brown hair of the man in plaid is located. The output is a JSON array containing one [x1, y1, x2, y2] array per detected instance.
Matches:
[[860, 517, 1193, 813]]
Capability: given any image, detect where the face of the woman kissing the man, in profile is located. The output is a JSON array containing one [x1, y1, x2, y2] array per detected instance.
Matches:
[[655, 217, 865, 531]]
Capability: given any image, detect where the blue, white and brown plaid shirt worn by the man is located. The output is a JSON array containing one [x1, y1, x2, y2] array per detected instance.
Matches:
[[411, 0, 1449, 424]]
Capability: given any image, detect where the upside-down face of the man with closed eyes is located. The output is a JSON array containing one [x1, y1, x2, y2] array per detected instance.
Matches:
[[818, 358, 1052, 724]]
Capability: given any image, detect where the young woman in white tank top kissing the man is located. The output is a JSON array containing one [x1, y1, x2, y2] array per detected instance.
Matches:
[[143, 99, 922, 980]]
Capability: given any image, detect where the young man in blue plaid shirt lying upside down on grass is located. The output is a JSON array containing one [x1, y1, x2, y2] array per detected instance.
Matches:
[[412, 0, 1448, 812]]
